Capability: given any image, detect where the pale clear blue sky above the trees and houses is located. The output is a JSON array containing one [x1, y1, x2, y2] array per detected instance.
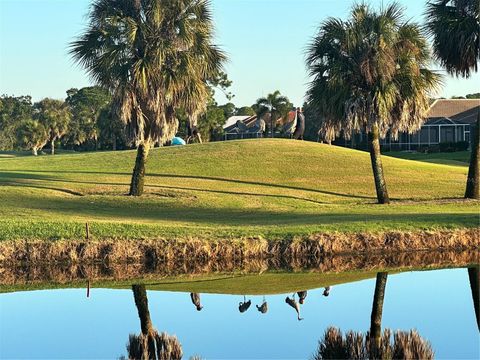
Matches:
[[0, 0, 480, 106]]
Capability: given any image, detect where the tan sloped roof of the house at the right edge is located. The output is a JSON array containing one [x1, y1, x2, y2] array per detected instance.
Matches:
[[427, 99, 480, 125]]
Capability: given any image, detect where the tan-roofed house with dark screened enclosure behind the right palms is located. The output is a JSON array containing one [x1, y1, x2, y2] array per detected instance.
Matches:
[[336, 99, 480, 151]]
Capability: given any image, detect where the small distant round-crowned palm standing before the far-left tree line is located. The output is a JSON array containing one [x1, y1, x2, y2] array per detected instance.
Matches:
[[34, 98, 72, 155]]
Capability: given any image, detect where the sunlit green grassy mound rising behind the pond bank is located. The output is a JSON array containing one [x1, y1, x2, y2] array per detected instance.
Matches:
[[0, 139, 479, 239]]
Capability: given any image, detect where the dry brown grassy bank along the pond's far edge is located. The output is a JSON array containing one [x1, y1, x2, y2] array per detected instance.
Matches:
[[0, 228, 480, 266]]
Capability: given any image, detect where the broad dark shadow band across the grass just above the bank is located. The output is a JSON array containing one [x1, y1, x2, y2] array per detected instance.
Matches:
[[2, 193, 478, 226]]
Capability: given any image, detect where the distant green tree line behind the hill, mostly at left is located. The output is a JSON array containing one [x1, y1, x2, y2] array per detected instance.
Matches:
[[0, 73, 266, 155]]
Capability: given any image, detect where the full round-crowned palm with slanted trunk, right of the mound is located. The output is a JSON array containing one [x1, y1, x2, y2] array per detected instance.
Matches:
[[307, 3, 440, 204]]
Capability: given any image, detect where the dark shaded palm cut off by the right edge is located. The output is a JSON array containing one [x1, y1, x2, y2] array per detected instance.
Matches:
[[426, 0, 480, 199]]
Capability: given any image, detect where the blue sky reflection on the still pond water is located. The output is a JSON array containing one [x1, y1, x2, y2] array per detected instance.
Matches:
[[0, 269, 480, 359]]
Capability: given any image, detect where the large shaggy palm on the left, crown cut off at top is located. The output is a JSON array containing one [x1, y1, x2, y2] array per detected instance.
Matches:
[[71, 0, 226, 196]]
